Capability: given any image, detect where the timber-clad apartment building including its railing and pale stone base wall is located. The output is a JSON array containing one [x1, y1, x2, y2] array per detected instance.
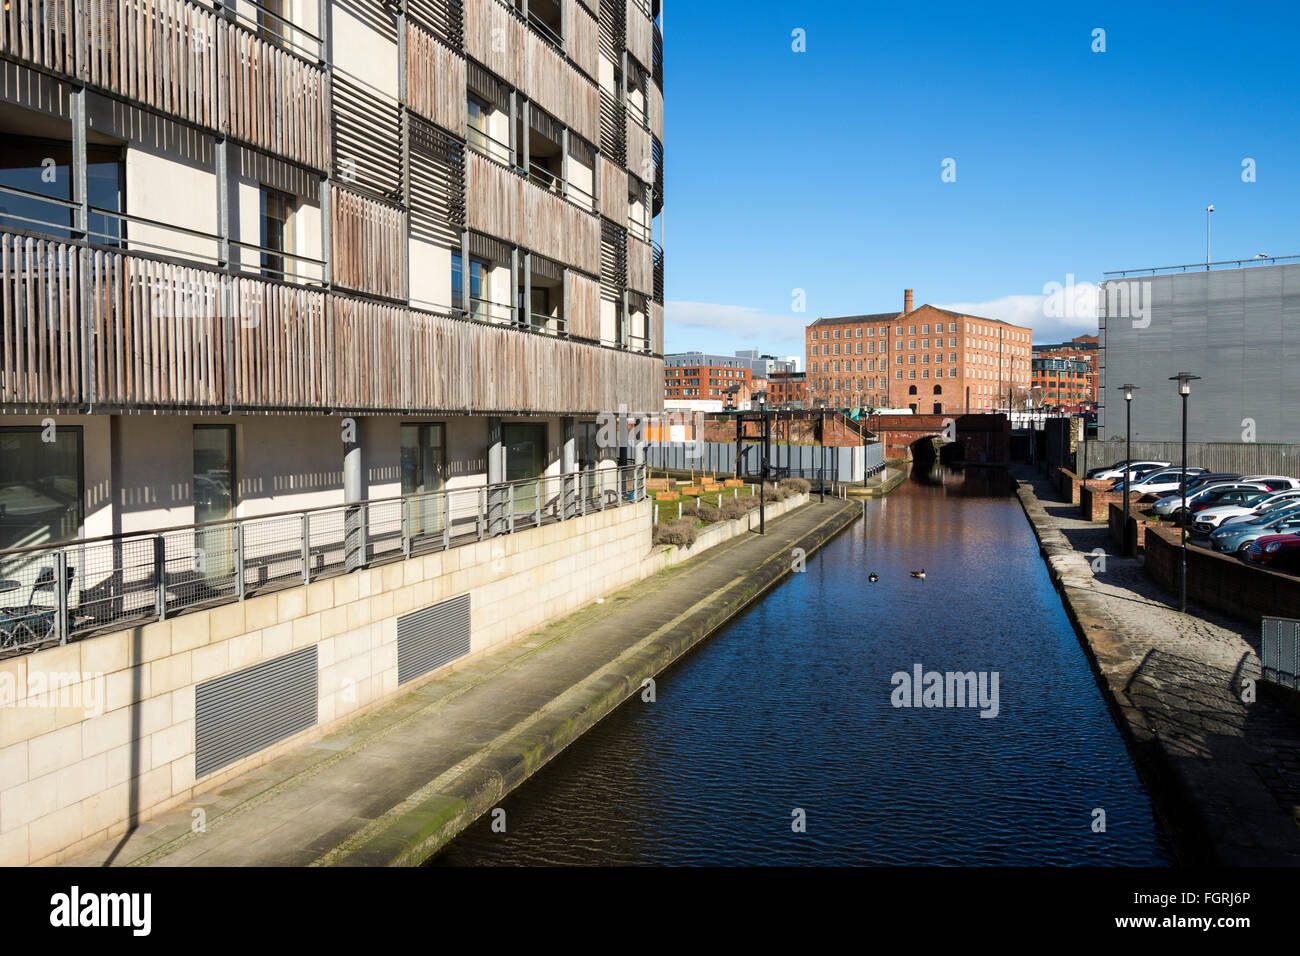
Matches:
[[0, 0, 663, 865]]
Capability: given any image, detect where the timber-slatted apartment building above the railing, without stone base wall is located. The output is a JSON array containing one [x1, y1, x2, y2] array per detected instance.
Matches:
[[0, 0, 663, 549]]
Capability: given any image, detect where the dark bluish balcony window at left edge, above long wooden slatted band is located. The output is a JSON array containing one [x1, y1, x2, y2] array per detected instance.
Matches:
[[0, 134, 126, 243]]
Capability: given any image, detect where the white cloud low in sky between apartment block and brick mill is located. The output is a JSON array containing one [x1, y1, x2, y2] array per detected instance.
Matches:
[[664, 302, 811, 355]]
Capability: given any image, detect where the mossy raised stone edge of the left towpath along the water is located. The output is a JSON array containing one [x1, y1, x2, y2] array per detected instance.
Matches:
[[319, 501, 862, 866]]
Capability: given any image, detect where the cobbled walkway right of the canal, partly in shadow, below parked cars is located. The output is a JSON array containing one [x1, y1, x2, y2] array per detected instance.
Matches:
[[1013, 467, 1300, 865]]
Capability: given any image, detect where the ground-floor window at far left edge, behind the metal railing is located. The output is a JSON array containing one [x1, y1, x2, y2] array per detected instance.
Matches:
[[0, 425, 86, 554]]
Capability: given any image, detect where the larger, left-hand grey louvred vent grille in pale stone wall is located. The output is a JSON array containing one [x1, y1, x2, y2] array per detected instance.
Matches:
[[194, 645, 319, 777]]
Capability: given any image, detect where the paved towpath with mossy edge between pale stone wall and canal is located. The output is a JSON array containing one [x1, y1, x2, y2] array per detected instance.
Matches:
[[69, 499, 861, 866]]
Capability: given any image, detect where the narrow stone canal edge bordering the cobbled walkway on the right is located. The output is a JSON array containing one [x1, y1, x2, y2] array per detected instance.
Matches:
[[1017, 480, 1227, 865]]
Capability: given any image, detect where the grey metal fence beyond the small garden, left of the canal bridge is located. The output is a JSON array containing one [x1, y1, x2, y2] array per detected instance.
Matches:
[[645, 441, 884, 484]]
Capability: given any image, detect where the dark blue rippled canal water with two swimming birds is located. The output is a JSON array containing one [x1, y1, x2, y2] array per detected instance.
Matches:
[[433, 471, 1173, 865]]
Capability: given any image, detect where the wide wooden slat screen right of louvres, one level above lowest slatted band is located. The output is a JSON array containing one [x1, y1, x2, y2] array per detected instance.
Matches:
[[467, 153, 601, 273]]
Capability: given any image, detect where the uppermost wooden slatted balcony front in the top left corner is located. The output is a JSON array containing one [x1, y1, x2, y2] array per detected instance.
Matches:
[[0, 0, 329, 170]]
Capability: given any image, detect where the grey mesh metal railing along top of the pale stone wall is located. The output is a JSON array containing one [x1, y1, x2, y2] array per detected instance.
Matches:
[[0, 466, 646, 654]]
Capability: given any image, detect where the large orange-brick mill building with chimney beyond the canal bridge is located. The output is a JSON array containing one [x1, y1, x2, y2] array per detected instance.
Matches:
[[805, 289, 1034, 414]]
